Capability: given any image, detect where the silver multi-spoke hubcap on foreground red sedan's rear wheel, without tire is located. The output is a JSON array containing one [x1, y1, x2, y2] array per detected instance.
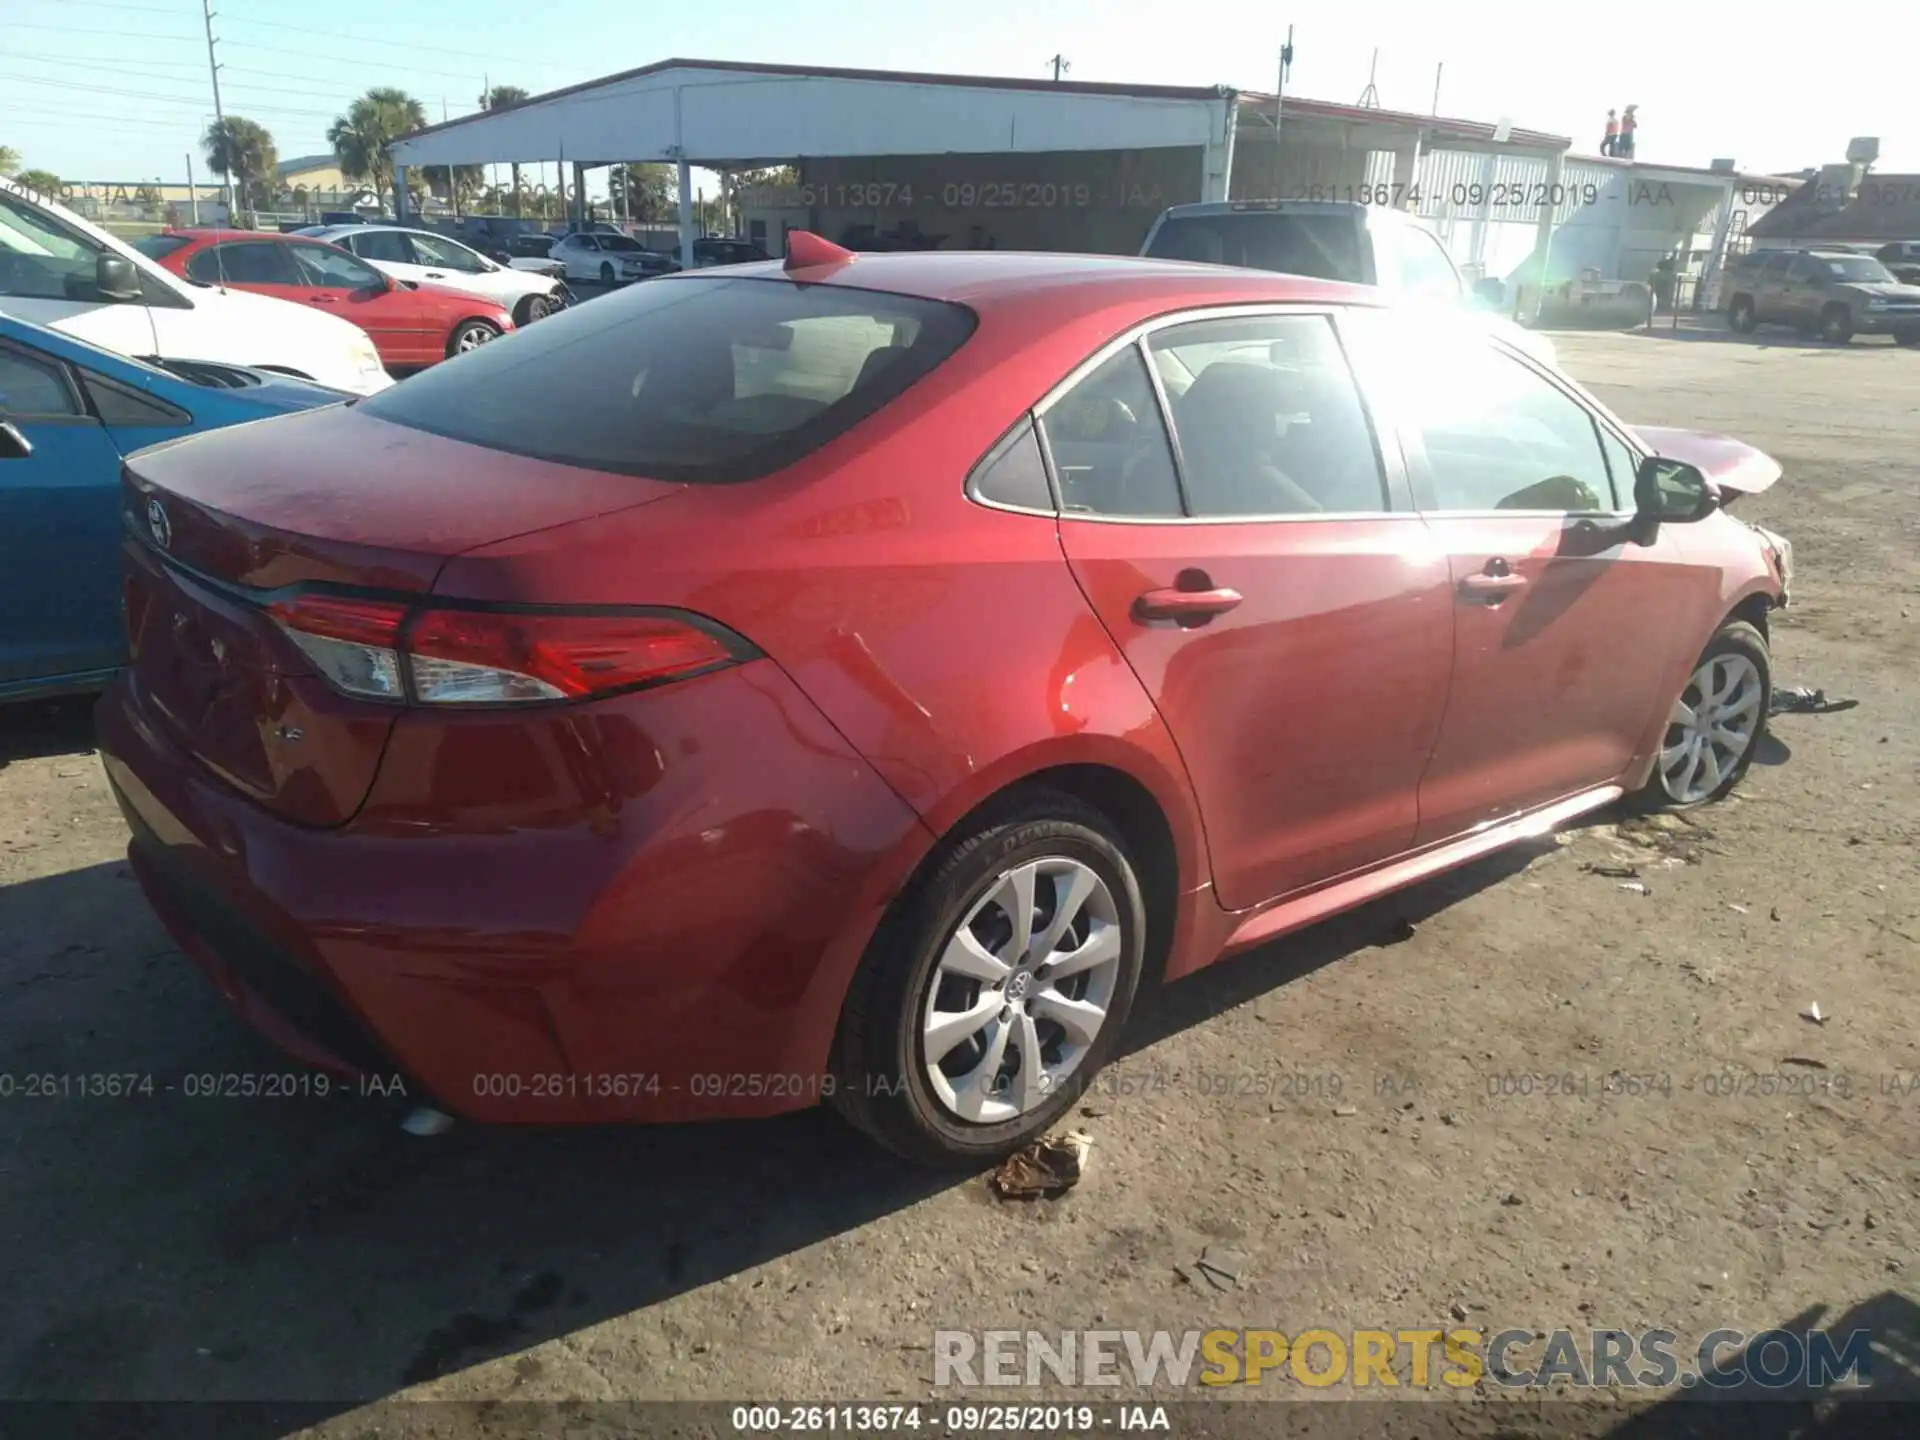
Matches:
[[920, 856, 1121, 1125]]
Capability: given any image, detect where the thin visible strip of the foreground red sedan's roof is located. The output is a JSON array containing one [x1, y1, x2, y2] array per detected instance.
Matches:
[[649, 250, 1380, 309]]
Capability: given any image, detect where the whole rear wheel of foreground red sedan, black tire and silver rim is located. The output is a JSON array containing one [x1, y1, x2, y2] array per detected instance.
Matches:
[[833, 791, 1146, 1165]]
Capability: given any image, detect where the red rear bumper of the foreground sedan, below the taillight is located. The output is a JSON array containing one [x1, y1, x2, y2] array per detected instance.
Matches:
[[98, 662, 920, 1123]]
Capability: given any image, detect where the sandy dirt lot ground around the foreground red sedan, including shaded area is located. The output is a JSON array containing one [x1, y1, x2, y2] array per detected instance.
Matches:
[[0, 320, 1920, 1434]]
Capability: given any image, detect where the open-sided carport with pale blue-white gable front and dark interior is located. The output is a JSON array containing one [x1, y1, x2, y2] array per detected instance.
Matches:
[[392, 60, 1235, 265]]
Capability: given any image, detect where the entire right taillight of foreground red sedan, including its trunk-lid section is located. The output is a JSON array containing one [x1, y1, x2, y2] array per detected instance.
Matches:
[[269, 595, 737, 705]]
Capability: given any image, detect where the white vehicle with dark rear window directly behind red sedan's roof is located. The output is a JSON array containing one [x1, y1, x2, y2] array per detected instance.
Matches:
[[1140, 200, 1555, 365]]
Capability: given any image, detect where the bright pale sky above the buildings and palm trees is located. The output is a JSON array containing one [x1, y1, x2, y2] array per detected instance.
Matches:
[[0, 0, 1920, 188]]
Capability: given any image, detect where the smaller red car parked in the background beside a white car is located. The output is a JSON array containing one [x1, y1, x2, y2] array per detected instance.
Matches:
[[138, 230, 513, 369]]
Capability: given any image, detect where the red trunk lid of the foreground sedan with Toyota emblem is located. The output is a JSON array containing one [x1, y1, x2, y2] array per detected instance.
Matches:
[[123, 405, 680, 826]]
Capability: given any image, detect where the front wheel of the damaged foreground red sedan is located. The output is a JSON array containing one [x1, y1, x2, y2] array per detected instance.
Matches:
[[1634, 620, 1774, 810]]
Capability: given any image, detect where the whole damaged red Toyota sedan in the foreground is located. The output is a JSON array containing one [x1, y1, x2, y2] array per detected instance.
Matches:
[[100, 236, 1789, 1162]]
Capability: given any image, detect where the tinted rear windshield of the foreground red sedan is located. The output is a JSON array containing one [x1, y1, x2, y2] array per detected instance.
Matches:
[[361, 276, 973, 482]]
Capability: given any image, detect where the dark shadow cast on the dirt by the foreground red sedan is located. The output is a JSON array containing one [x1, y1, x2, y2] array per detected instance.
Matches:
[[0, 791, 1574, 1434]]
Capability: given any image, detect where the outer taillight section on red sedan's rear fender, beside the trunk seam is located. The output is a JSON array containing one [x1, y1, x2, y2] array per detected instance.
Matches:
[[407, 611, 732, 705]]
